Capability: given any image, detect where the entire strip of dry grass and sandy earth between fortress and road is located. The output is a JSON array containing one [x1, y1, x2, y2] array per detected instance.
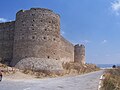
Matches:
[[0, 62, 100, 78]]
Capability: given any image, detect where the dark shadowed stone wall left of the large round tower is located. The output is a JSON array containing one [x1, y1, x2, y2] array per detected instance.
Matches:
[[0, 21, 15, 64]]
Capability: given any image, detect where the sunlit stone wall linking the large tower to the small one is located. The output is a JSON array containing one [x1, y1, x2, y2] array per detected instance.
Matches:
[[60, 36, 74, 63]]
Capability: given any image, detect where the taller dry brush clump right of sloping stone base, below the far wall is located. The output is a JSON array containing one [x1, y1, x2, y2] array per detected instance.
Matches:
[[63, 62, 100, 75]]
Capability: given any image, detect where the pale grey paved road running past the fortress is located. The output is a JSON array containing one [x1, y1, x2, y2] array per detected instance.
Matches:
[[0, 70, 103, 90]]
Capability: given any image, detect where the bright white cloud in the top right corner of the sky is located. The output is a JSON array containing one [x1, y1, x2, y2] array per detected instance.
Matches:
[[111, 0, 120, 15]]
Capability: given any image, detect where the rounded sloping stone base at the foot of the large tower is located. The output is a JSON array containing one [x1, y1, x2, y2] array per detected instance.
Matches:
[[15, 57, 63, 72]]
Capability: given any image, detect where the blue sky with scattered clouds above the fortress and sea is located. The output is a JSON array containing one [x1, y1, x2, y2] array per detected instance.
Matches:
[[0, 0, 120, 64]]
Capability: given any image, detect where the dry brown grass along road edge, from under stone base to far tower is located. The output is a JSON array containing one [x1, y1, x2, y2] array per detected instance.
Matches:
[[22, 62, 100, 78]]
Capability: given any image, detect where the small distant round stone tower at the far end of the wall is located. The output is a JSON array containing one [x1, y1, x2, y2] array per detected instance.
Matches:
[[74, 44, 85, 64]]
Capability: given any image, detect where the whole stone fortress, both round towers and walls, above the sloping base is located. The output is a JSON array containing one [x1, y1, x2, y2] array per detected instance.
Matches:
[[0, 8, 85, 70]]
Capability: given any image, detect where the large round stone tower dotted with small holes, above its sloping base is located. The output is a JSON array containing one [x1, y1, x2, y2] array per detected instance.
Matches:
[[11, 8, 60, 66]]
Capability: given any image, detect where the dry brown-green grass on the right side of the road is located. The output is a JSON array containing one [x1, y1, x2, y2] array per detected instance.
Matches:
[[102, 68, 120, 90]]
